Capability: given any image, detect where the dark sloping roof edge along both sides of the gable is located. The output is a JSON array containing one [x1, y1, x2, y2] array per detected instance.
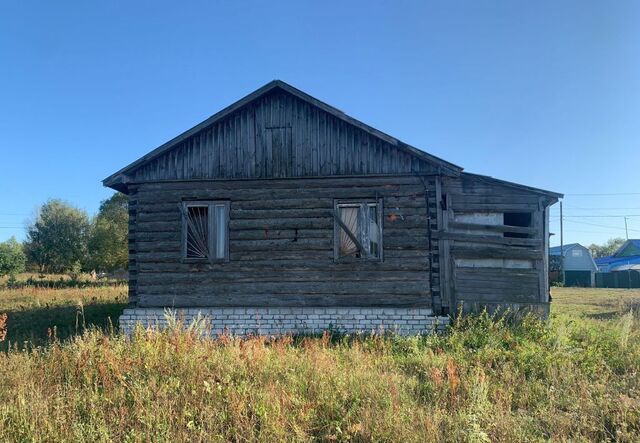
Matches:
[[102, 80, 462, 189]]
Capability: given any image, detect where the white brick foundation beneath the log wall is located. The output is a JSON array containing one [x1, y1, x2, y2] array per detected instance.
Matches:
[[120, 307, 449, 335]]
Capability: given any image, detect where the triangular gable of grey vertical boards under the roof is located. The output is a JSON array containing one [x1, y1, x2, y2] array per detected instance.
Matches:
[[129, 89, 437, 183]]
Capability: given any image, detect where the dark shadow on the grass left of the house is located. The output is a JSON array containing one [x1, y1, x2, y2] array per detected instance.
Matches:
[[0, 302, 127, 351]]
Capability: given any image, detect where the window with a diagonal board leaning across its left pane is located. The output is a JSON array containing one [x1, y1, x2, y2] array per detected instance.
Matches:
[[334, 201, 382, 260]]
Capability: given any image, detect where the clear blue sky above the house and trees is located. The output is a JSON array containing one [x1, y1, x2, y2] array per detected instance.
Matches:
[[0, 0, 640, 244]]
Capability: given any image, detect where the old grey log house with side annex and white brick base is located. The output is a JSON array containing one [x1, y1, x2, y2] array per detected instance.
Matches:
[[103, 81, 561, 333]]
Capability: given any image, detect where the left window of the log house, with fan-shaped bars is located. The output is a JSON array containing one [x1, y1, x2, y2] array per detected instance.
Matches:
[[181, 201, 229, 262]]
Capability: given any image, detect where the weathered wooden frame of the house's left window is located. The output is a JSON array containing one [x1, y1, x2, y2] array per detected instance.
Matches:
[[180, 200, 230, 263]]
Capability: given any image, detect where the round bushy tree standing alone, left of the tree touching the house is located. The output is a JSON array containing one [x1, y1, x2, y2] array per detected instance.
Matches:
[[25, 200, 89, 272]]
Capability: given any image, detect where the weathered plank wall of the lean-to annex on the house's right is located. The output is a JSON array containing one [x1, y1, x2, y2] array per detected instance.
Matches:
[[435, 174, 549, 311]]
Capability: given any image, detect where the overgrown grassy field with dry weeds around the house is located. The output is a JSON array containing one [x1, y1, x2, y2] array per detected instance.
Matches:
[[0, 287, 640, 442]]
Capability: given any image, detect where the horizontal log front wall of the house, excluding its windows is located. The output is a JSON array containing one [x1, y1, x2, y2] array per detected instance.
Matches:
[[130, 176, 437, 307]]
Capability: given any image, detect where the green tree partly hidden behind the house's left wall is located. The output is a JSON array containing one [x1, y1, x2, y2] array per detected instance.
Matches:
[[87, 192, 129, 271]]
